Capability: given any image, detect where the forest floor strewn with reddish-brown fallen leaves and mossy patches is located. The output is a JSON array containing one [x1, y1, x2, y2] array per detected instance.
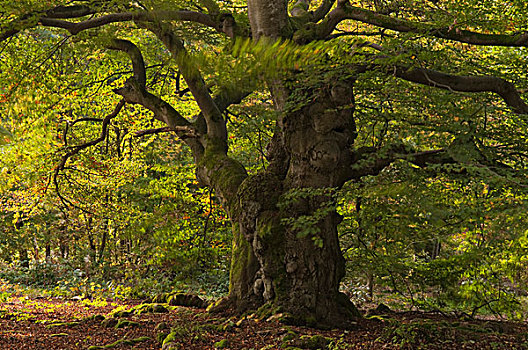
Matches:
[[0, 296, 528, 350]]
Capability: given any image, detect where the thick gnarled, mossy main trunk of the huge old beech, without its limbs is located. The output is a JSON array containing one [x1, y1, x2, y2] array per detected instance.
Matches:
[[214, 78, 358, 325]]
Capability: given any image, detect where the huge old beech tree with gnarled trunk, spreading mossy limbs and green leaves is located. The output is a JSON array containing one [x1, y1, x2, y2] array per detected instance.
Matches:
[[0, 0, 528, 325]]
